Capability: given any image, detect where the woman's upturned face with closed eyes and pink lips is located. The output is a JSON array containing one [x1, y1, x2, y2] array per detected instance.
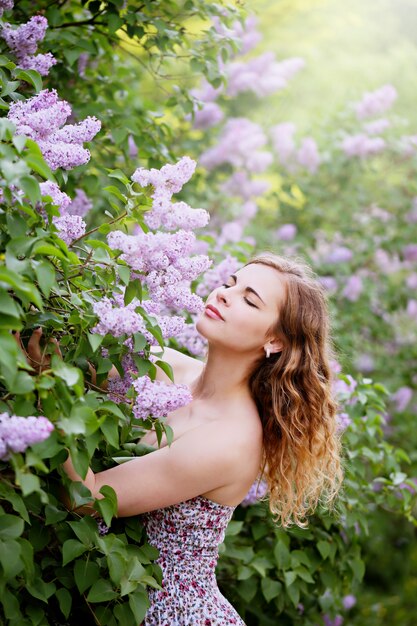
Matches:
[[197, 263, 286, 356]]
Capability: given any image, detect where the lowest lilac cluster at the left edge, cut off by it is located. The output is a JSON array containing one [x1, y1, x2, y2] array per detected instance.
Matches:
[[0, 413, 54, 461]]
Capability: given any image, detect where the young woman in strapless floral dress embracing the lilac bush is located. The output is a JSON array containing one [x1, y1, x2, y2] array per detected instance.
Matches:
[[29, 254, 341, 626]]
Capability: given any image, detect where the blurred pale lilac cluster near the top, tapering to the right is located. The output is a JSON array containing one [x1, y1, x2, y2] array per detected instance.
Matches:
[[226, 52, 305, 98]]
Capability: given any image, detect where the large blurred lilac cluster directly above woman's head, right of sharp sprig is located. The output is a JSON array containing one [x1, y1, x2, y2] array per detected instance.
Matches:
[[200, 117, 272, 172]]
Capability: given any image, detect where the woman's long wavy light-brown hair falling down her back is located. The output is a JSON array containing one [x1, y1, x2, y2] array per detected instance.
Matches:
[[247, 253, 343, 527]]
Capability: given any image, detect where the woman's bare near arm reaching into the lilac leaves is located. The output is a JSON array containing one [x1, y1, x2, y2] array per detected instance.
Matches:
[[63, 422, 245, 517]]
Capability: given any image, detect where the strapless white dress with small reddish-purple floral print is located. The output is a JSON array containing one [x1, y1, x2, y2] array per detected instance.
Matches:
[[143, 496, 245, 626]]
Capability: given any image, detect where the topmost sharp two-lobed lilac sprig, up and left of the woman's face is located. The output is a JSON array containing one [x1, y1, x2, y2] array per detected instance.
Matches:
[[132, 156, 210, 231]]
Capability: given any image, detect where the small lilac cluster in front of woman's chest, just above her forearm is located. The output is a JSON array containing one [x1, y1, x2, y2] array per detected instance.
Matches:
[[133, 376, 192, 419]]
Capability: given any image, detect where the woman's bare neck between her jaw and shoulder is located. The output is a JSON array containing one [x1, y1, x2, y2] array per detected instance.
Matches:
[[193, 347, 253, 400]]
